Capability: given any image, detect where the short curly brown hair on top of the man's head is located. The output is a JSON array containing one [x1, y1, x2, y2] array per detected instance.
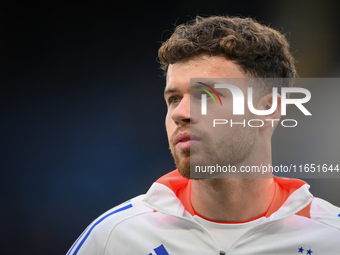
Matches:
[[158, 16, 296, 78]]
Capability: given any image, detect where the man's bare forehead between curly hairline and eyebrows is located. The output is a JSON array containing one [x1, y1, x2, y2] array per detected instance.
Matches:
[[166, 55, 245, 89]]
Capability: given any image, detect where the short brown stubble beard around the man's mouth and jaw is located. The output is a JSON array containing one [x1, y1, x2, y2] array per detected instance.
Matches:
[[170, 124, 256, 179]]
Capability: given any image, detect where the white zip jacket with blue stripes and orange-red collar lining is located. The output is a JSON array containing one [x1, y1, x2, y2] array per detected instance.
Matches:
[[67, 170, 340, 255]]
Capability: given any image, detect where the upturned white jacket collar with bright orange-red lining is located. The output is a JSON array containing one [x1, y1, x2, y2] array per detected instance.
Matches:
[[143, 170, 313, 220]]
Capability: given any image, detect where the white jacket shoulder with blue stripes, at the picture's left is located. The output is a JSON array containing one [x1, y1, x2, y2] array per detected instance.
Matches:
[[67, 195, 153, 255]]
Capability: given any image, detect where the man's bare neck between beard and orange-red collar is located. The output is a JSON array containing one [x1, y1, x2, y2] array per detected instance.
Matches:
[[191, 178, 275, 222]]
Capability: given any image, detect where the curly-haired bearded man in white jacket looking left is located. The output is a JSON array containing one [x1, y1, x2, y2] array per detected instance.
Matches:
[[68, 17, 340, 255]]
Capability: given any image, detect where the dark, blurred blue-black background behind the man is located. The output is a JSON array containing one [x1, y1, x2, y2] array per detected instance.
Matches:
[[0, 0, 340, 255]]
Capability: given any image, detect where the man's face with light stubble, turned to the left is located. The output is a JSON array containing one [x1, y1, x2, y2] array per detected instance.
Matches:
[[164, 55, 256, 178]]
